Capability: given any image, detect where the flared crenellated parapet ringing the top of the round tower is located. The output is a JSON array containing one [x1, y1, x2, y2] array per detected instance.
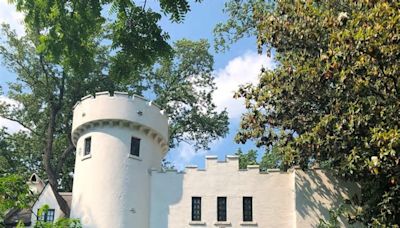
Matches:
[[72, 92, 169, 153]]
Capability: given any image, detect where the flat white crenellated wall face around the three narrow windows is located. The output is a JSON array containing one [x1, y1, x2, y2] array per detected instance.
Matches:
[[150, 156, 295, 228]]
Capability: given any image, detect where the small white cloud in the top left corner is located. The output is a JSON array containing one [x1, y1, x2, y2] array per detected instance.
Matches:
[[0, 0, 25, 35]]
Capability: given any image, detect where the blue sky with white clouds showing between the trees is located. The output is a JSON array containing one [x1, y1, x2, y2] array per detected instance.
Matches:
[[0, 0, 274, 169]]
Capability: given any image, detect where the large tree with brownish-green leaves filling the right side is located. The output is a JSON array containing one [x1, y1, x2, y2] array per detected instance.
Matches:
[[216, 0, 400, 227]]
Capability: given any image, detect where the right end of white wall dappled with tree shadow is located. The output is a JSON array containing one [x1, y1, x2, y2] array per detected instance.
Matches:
[[295, 169, 359, 227]]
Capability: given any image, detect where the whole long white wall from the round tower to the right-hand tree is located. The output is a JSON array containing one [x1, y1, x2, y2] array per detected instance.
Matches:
[[150, 159, 359, 228]]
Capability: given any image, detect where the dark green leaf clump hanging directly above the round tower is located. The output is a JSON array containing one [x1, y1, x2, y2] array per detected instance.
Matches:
[[110, 6, 171, 81]]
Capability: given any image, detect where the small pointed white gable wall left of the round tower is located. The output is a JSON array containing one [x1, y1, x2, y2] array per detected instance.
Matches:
[[31, 184, 64, 227]]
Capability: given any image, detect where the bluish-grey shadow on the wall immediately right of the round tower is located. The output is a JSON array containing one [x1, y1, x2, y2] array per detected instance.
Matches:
[[150, 170, 184, 228]]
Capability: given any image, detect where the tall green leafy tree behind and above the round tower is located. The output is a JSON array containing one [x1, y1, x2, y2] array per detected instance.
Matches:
[[0, 0, 227, 216]]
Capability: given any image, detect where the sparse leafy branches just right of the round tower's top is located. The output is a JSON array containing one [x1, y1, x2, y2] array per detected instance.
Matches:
[[147, 40, 228, 149]]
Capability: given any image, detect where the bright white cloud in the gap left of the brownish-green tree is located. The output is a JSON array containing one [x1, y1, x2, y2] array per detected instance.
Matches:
[[213, 52, 274, 121]]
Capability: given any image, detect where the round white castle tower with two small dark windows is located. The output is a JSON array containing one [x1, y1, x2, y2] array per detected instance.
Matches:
[[71, 92, 168, 228]]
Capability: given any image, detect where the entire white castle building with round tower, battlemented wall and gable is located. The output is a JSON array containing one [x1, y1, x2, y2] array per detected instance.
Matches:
[[3, 92, 356, 228]]
